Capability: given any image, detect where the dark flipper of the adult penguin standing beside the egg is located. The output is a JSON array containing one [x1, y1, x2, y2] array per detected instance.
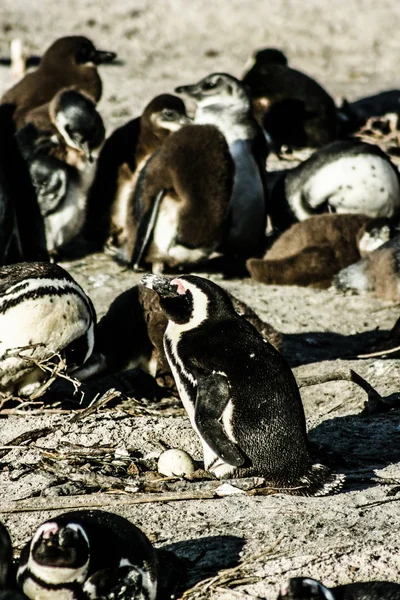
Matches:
[[195, 373, 245, 467]]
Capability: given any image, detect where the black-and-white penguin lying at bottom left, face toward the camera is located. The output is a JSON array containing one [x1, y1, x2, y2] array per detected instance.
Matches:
[[17, 510, 158, 600]]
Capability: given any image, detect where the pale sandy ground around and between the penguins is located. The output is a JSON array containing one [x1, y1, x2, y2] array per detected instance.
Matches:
[[0, 0, 400, 600]]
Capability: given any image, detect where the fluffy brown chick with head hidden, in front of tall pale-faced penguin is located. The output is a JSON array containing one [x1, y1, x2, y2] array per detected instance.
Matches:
[[125, 125, 234, 272]]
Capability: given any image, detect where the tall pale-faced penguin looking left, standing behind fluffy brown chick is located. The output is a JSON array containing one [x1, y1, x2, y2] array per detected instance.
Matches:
[[175, 73, 268, 257]]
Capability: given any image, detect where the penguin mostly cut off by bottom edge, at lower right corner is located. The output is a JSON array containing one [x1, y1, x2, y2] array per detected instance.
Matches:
[[278, 577, 400, 600]]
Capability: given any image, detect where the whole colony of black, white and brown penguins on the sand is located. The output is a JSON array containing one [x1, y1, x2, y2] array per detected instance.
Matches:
[[0, 36, 400, 600]]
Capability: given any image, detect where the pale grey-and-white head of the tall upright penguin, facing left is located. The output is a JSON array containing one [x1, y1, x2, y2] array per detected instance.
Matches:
[[175, 73, 250, 109]]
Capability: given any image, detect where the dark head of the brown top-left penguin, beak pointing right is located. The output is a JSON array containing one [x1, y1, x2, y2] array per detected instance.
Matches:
[[40, 35, 117, 69]]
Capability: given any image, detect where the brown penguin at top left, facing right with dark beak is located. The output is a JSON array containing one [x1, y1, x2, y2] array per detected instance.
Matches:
[[1, 36, 116, 128]]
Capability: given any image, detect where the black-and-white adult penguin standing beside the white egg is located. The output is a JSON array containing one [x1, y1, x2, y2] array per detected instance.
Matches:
[[142, 275, 342, 495]]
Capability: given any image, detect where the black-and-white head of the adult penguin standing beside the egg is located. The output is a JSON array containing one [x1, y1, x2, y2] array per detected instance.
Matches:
[[141, 275, 236, 330]]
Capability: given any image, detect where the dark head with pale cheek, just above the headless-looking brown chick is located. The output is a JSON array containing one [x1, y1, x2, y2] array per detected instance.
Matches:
[[140, 94, 192, 140]]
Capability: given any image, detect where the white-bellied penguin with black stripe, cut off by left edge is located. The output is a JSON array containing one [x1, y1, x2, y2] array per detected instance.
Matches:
[[0, 263, 96, 395]]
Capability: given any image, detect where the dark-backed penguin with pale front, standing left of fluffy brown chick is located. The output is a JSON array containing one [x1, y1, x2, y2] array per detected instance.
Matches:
[[84, 94, 191, 255]]
